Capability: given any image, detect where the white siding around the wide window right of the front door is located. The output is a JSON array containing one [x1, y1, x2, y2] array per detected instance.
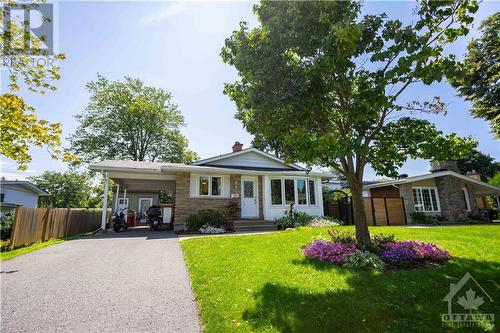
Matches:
[[263, 176, 324, 221]]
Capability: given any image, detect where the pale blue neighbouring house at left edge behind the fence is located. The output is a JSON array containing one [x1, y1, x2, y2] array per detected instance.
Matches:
[[0, 178, 48, 216]]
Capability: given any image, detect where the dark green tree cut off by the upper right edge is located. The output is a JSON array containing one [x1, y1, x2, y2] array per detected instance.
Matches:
[[451, 12, 500, 138]]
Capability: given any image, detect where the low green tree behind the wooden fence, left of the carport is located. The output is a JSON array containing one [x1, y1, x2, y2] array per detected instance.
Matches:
[[29, 171, 102, 208]]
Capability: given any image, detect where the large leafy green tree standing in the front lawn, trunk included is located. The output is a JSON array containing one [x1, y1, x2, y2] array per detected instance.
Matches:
[[221, 1, 477, 244]]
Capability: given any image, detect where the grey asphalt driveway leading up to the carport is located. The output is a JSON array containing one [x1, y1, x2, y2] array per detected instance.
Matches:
[[0, 229, 201, 332]]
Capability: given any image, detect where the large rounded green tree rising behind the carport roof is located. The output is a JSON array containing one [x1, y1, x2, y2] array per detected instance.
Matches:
[[70, 75, 197, 162]]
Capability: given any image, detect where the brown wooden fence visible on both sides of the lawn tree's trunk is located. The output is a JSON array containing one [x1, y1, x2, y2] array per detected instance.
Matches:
[[325, 197, 407, 226]]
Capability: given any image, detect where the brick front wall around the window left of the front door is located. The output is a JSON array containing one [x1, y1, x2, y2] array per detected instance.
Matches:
[[174, 172, 241, 231]]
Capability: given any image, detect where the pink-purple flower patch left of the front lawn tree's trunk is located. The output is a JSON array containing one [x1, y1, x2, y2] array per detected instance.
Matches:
[[302, 240, 356, 264]]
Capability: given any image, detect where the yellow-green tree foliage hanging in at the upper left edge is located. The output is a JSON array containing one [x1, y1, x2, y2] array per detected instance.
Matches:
[[0, 1, 66, 170]]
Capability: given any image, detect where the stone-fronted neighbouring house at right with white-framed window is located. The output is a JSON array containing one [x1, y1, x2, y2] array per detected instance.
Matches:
[[363, 161, 500, 223]]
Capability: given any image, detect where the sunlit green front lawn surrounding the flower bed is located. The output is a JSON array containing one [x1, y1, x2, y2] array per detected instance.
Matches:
[[181, 225, 500, 333]]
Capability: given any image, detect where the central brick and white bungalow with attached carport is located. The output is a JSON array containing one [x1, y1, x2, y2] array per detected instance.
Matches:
[[90, 142, 331, 230]]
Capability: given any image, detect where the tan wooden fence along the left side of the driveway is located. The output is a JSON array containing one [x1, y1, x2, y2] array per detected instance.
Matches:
[[10, 206, 105, 248]]
